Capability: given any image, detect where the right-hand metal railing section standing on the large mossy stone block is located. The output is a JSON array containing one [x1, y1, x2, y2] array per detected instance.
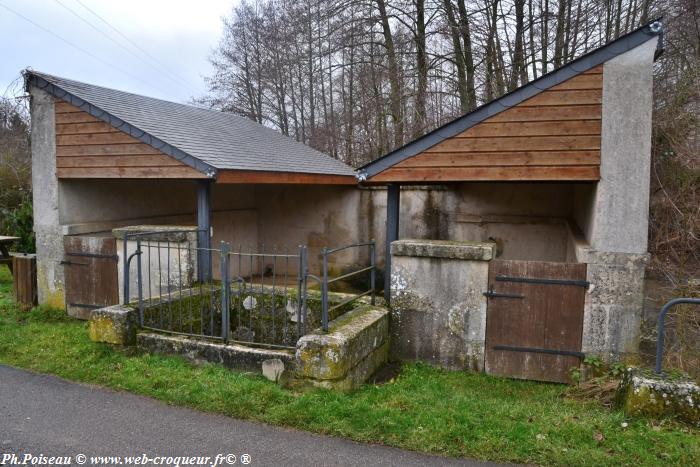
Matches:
[[306, 240, 377, 332]]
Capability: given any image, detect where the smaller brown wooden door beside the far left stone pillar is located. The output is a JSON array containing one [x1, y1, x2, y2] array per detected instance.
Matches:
[[62, 235, 119, 319]]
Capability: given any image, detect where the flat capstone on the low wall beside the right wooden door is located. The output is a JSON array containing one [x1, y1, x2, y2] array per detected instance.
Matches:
[[391, 240, 496, 261]]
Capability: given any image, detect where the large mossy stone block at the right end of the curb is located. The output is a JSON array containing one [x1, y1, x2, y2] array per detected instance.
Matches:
[[296, 305, 389, 389]]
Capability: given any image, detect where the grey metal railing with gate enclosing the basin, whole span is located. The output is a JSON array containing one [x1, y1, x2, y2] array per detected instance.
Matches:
[[123, 234, 376, 348]]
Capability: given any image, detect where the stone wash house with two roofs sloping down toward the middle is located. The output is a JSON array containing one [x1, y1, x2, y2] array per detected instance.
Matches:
[[25, 22, 662, 381]]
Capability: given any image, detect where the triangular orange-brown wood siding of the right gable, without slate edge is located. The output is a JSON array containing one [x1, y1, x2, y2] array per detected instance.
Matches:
[[370, 66, 603, 183]]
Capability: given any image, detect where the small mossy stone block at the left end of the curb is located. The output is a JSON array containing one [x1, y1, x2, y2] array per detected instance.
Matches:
[[88, 305, 138, 345]]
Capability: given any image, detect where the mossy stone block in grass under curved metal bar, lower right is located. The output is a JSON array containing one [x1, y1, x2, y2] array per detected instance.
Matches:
[[616, 368, 700, 426]]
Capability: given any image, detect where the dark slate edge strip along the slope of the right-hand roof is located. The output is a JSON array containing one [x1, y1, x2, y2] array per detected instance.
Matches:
[[357, 19, 663, 182]]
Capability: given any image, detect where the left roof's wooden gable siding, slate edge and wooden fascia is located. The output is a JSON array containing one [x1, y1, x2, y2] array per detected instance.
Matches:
[[26, 72, 357, 185]]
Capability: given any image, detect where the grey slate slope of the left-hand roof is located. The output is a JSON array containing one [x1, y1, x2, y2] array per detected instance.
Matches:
[[24, 70, 355, 177]]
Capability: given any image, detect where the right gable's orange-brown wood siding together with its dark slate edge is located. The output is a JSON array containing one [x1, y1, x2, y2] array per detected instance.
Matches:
[[357, 21, 662, 185]]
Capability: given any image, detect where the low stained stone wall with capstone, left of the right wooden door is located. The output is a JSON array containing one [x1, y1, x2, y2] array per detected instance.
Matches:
[[391, 240, 496, 371]]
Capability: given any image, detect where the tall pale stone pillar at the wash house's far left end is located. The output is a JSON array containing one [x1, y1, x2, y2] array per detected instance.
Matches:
[[29, 87, 65, 308]]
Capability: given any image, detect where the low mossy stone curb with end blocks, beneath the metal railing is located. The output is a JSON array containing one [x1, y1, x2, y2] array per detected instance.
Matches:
[[89, 305, 389, 391]]
